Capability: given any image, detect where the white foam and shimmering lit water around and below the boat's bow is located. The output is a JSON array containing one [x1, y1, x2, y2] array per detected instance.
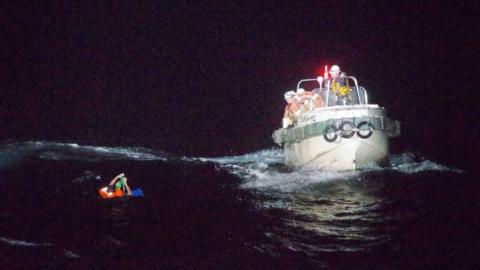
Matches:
[[198, 149, 463, 255]]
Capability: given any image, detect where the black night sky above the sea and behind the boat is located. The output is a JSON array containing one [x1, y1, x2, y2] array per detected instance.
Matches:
[[0, 1, 480, 169]]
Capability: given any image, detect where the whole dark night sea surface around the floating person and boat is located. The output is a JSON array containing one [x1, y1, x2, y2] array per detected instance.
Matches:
[[0, 142, 480, 269]]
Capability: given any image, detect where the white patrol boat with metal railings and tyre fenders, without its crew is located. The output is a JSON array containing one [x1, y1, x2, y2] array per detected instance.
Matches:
[[272, 76, 400, 171]]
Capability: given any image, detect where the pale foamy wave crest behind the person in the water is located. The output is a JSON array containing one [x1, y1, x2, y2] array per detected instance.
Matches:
[[0, 141, 167, 168]]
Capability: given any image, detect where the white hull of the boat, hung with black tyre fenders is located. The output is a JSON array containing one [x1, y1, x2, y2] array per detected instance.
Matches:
[[276, 105, 399, 171]]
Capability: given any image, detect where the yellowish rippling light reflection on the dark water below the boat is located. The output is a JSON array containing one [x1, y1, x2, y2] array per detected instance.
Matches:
[[267, 180, 388, 251]]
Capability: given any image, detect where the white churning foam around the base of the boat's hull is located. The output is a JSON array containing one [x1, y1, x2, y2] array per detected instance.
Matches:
[[204, 148, 463, 192]]
